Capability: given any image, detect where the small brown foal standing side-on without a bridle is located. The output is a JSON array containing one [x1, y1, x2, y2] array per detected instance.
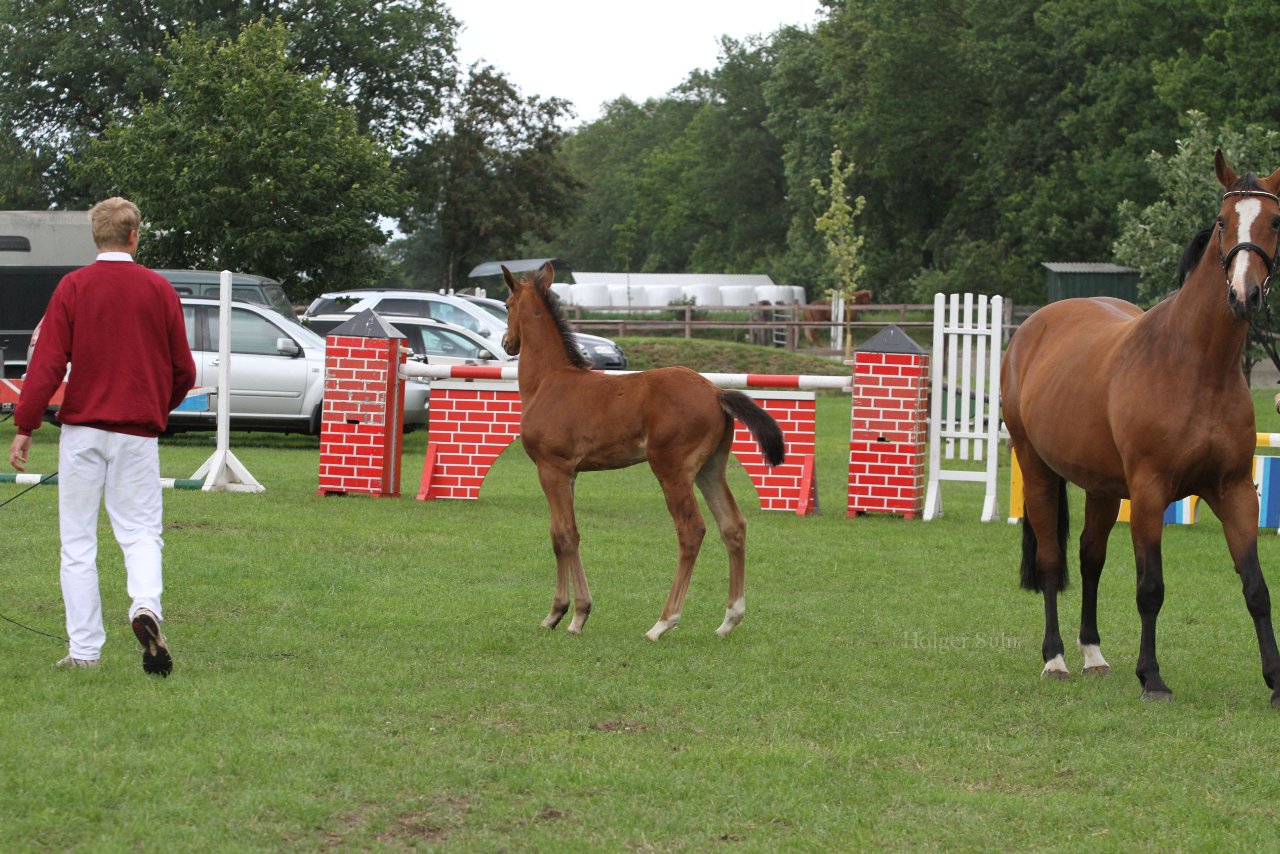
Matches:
[[502, 264, 786, 640]]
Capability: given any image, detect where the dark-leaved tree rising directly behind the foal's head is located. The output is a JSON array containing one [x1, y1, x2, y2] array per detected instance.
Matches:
[[401, 65, 581, 288]]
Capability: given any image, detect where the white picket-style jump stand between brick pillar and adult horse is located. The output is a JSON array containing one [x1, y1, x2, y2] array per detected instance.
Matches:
[[924, 293, 1004, 522]]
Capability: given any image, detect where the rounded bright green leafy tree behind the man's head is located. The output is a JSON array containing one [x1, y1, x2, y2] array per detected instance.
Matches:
[[72, 23, 403, 298]]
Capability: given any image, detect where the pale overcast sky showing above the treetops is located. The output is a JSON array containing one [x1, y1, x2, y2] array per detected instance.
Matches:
[[444, 0, 819, 124]]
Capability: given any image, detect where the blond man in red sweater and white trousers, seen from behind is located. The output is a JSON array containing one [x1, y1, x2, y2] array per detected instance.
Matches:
[[9, 197, 196, 676]]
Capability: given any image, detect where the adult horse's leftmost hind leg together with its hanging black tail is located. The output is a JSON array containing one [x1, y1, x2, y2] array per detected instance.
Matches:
[[1015, 443, 1070, 679]]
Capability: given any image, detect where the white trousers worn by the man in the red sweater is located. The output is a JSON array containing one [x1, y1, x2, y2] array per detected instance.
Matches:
[[58, 425, 164, 658]]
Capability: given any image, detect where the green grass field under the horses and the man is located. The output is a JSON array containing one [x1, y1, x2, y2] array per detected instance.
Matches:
[[0, 389, 1280, 851]]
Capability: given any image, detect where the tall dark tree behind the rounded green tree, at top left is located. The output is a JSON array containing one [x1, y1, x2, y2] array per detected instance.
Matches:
[[0, 0, 457, 202]]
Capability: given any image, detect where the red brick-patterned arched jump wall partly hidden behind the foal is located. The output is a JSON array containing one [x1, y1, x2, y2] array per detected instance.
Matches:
[[417, 380, 817, 512]]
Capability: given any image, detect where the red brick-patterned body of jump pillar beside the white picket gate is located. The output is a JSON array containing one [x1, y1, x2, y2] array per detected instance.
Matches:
[[846, 352, 929, 519]]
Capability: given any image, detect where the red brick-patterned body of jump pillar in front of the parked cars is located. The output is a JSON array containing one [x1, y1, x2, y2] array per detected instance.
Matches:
[[316, 335, 404, 497]]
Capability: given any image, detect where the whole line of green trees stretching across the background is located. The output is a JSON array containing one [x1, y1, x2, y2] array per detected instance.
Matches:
[[0, 0, 1280, 303]]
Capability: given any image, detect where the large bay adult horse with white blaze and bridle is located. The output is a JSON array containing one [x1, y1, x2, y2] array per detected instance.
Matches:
[[1001, 151, 1280, 707]]
